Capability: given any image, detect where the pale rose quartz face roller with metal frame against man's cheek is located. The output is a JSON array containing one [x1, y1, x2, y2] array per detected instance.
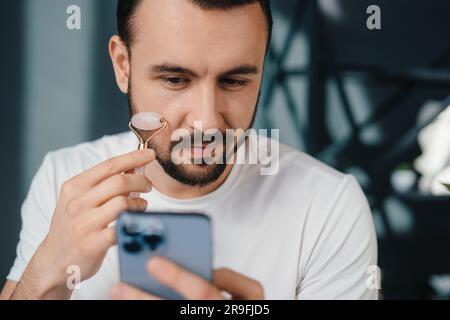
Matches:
[[129, 112, 167, 198]]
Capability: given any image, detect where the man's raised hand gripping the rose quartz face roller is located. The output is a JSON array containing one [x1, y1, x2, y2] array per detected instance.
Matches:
[[12, 150, 155, 299]]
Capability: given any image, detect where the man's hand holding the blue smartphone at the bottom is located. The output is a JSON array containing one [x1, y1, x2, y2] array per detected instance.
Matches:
[[111, 257, 264, 300]]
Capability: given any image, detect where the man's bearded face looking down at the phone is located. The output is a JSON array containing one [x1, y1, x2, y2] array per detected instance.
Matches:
[[114, 0, 267, 186]]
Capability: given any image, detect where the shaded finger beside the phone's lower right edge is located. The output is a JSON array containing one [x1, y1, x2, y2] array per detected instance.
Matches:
[[213, 268, 264, 300]]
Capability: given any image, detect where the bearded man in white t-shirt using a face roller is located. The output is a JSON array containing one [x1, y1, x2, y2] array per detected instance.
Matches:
[[2, 0, 377, 299]]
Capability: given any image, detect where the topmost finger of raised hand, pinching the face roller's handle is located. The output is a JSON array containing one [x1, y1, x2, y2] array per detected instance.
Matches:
[[67, 149, 155, 189]]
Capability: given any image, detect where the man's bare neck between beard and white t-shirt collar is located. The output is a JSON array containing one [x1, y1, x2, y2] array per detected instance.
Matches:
[[145, 160, 233, 199]]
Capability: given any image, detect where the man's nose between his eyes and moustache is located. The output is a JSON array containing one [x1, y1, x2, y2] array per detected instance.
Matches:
[[187, 85, 224, 130]]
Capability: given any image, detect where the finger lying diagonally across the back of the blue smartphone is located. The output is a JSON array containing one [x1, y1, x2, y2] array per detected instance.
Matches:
[[147, 257, 223, 300]]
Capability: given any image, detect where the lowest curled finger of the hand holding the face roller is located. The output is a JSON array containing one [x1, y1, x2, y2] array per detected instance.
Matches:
[[92, 196, 148, 229]]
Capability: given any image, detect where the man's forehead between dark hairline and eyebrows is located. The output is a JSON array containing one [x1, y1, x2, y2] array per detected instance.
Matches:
[[132, 0, 267, 72]]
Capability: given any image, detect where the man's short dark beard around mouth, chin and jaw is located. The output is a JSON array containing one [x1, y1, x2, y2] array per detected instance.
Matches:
[[127, 79, 261, 188]]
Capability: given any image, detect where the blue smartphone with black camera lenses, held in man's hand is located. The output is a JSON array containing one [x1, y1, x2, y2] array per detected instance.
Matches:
[[116, 211, 212, 300]]
